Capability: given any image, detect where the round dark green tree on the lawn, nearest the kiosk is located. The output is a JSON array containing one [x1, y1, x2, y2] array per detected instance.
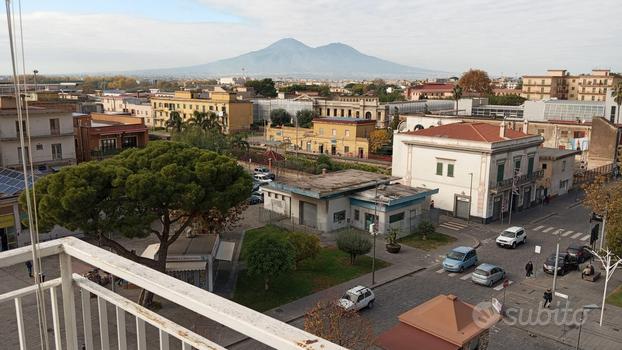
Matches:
[[246, 235, 295, 290]]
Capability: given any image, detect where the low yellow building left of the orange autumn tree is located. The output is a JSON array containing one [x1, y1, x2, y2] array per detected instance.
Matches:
[[267, 117, 376, 158]]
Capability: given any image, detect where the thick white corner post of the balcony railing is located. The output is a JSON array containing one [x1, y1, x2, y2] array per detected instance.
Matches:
[[59, 253, 78, 350]]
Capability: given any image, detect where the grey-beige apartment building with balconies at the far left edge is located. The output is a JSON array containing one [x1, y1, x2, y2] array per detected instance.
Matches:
[[0, 96, 76, 171]]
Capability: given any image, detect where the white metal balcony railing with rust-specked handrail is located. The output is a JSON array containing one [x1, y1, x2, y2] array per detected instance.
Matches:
[[0, 237, 343, 350]]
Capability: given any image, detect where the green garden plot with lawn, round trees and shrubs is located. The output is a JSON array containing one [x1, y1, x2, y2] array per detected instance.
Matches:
[[233, 225, 389, 311]]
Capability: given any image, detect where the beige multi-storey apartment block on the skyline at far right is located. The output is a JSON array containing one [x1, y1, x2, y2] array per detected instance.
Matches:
[[521, 69, 622, 101]]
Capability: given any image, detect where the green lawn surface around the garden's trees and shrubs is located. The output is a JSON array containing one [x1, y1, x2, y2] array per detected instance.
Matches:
[[233, 225, 389, 311]]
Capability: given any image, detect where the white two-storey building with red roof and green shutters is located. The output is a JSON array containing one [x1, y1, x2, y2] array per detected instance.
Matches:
[[392, 123, 544, 223]]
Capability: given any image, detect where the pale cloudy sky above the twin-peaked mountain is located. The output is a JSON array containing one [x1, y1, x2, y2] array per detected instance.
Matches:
[[0, 0, 622, 75]]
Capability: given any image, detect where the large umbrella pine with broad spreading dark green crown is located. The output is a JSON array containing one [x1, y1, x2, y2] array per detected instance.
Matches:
[[20, 142, 252, 304]]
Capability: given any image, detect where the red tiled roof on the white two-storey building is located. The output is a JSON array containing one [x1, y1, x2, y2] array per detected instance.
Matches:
[[407, 122, 533, 142]]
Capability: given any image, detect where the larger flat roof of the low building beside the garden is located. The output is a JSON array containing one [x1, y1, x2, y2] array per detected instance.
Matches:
[[269, 169, 397, 198]]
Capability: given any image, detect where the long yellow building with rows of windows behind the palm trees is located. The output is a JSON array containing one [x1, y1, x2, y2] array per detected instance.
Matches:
[[151, 90, 253, 133]]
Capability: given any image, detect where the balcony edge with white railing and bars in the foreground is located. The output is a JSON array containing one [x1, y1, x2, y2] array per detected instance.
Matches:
[[0, 237, 343, 350]]
